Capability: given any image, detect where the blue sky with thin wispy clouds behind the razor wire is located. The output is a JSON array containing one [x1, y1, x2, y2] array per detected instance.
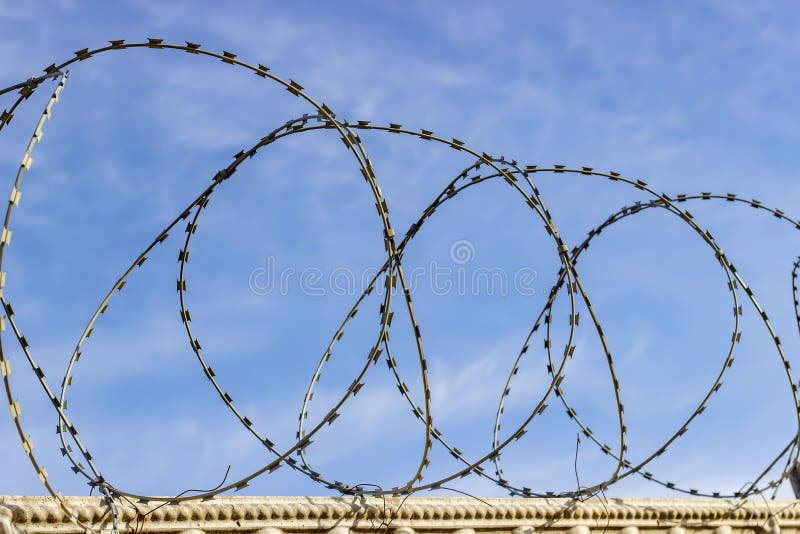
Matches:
[[0, 0, 800, 502]]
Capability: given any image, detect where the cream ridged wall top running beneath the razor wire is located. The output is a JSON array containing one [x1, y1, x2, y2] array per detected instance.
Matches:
[[0, 496, 800, 534]]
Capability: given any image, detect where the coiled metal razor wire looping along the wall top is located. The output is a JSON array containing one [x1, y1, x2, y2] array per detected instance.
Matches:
[[0, 39, 800, 530]]
